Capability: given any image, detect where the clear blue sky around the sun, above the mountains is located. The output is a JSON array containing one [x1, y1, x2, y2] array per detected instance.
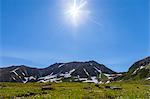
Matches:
[[0, 0, 150, 71]]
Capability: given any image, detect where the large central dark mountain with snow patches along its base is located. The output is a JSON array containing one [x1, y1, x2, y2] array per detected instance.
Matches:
[[39, 61, 117, 83]]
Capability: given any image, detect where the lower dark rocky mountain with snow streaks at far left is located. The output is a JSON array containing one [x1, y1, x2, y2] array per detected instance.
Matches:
[[0, 65, 41, 82]]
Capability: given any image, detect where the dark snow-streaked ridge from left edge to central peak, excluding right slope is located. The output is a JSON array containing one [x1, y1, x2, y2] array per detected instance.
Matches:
[[0, 61, 118, 83]]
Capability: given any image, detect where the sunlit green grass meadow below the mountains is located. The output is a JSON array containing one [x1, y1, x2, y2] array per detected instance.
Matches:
[[0, 81, 150, 99]]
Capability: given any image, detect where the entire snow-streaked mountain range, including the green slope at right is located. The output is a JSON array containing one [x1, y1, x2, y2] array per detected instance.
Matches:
[[0, 57, 150, 83]]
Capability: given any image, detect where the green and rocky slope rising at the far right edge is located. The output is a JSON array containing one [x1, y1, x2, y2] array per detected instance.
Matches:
[[117, 57, 150, 80]]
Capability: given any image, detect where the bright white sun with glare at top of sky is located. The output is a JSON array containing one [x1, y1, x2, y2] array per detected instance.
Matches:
[[67, 0, 87, 26]]
